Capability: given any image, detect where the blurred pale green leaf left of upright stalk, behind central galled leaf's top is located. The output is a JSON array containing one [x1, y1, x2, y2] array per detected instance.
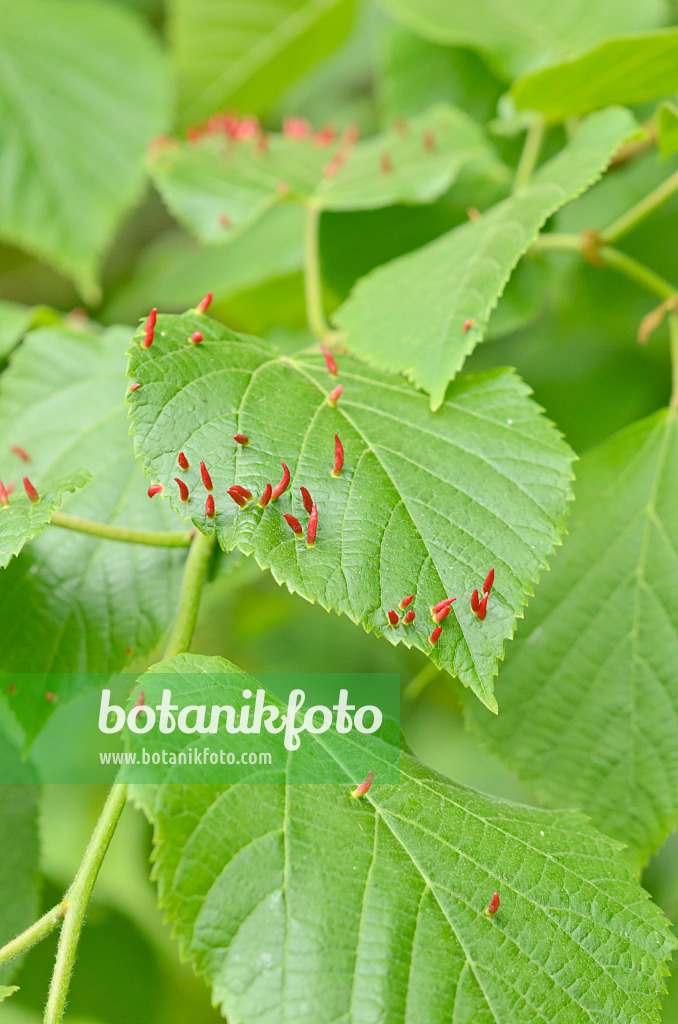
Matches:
[[105, 203, 303, 321]]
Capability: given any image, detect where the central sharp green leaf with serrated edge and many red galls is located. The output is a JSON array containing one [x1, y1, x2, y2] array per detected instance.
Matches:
[[129, 314, 571, 707]]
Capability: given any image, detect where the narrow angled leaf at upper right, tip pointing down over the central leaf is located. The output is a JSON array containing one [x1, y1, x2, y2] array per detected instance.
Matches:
[[334, 110, 634, 409]]
